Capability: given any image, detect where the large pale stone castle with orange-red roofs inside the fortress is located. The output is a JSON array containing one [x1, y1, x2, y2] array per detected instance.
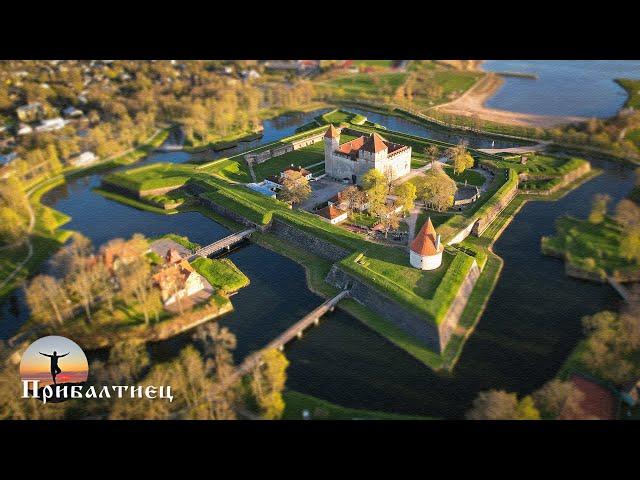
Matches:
[[324, 125, 411, 185]]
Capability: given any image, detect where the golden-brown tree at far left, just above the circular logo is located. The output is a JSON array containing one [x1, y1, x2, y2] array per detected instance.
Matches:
[[26, 275, 72, 325]]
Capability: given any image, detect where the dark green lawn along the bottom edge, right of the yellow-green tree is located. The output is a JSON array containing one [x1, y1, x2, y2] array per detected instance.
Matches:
[[282, 390, 431, 420]]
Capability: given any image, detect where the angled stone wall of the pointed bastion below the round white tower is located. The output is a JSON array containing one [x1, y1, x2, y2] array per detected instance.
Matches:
[[325, 262, 480, 353]]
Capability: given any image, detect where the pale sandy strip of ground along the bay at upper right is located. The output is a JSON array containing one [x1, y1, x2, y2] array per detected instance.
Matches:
[[427, 73, 588, 128]]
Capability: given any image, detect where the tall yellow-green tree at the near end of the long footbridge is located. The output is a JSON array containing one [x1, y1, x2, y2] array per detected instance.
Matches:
[[251, 349, 289, 420]]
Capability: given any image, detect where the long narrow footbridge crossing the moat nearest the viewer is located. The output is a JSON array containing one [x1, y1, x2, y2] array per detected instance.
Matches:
[[208, 289, 351, 398]]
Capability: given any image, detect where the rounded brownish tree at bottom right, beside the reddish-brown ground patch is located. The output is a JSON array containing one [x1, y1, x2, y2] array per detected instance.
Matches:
[[533, 379, 584, 419]]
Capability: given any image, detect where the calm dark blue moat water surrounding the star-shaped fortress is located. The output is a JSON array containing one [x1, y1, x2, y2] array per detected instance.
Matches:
[[0, 107, 633, 418]]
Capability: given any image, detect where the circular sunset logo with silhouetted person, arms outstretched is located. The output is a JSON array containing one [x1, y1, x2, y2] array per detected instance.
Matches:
[[20, 335, 89, 402]]
